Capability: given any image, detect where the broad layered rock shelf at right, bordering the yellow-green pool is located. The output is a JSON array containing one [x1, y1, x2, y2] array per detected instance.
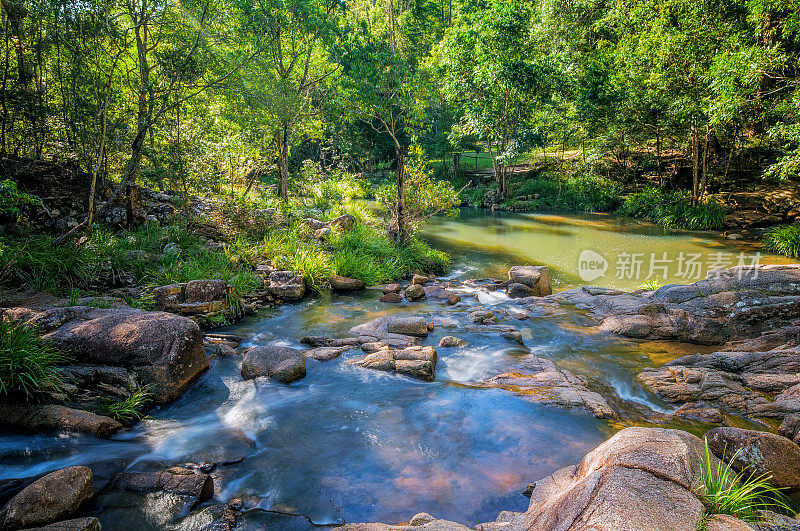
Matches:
[[544, 265, 800, 345]]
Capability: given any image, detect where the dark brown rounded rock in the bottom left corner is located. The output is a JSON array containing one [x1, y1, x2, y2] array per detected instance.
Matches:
[[3, 466, 94, 529]]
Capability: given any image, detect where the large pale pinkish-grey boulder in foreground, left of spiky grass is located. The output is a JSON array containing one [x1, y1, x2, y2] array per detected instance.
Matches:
[[512, 428, 704, 531]]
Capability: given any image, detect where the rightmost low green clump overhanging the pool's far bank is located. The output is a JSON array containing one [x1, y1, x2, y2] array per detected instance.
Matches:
[[616, 187, 725, 230]]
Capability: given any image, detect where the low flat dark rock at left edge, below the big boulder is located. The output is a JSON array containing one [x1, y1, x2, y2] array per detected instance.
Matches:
[[3, 404, 122, 437]]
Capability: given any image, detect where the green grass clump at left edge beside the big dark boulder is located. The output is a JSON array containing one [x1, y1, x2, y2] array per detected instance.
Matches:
[[0, 321, 67, 397]]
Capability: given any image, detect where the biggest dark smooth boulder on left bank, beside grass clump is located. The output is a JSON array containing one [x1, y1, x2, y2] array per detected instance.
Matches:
[[0, 306, 208, 403]]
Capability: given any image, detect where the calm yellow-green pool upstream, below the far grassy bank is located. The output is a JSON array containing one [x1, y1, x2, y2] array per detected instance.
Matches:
[[425, 209, 791, 289]]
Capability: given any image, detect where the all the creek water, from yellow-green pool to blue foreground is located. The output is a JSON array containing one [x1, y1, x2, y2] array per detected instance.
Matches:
[[0, 212, 784, 531]]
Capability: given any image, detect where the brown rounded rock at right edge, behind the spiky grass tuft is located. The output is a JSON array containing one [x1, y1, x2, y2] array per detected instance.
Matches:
[[705, 427, 800, 491]]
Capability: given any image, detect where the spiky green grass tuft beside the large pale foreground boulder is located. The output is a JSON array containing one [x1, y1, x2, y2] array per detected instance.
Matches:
[[695, 439, 792, 528]]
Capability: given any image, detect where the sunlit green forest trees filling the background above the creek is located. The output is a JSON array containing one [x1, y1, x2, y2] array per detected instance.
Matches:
[[0, 0, 800, 232]]
